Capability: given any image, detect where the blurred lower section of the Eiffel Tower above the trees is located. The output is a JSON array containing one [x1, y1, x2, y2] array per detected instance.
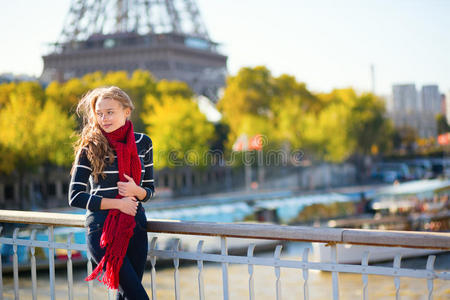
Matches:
[[41, 0, 227, 101]]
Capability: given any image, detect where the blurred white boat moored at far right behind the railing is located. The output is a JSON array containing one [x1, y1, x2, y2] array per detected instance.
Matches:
[[313, 179, 450, 264]]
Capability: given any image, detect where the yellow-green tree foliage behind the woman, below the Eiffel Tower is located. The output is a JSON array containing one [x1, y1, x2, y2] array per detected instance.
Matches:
[[0, 70, 218, 172]]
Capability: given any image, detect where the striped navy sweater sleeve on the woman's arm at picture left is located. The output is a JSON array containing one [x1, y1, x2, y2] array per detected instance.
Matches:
[[68, 148, 103, 211]]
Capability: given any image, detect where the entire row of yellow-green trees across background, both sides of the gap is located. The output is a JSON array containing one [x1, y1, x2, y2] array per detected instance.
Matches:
[[0, 66, 396, 176]]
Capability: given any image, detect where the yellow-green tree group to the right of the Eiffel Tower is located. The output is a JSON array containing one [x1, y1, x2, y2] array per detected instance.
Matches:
[[217, 67, 392, 162]]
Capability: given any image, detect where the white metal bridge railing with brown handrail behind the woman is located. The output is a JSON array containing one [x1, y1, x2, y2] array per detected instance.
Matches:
[[0, 210, 450, 300]]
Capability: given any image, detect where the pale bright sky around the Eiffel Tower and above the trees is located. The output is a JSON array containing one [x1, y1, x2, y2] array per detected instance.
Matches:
[[0, 0, 450, 94]]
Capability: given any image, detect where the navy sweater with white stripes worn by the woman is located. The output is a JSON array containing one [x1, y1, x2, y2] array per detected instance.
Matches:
[[68, 132, 155, 214]]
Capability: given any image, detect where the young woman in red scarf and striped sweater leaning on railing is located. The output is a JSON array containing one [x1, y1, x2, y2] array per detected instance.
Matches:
[[68, 86, 155, 299]]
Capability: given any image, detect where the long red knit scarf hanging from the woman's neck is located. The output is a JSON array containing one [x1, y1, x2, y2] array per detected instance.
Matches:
[[85, 120, 141, 289]]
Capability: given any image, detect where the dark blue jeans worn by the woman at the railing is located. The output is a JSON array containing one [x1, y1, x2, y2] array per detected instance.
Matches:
[[86, 203, 149, 300]]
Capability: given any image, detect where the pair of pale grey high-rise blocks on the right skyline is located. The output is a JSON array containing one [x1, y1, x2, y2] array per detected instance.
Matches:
[[387, 84, 442, 138]]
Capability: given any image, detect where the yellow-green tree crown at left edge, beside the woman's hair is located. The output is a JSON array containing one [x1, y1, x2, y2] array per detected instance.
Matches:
[[0, 88, 75, 173]]
